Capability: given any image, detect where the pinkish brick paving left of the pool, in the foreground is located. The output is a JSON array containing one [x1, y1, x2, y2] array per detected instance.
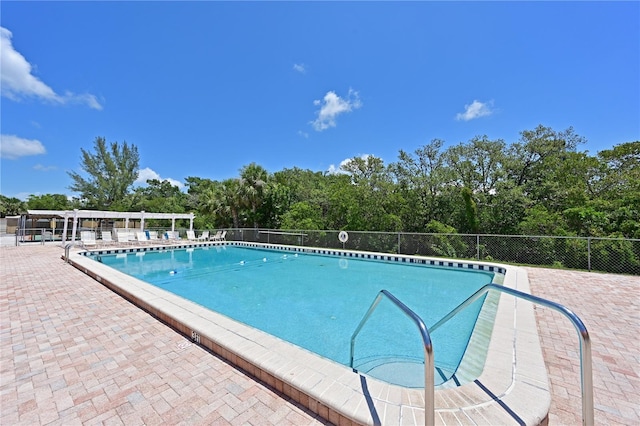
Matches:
[[0, 245, 325, 426]]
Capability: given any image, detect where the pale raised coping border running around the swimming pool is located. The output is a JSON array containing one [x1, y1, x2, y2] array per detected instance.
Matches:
[[68, 242, 551, 425]]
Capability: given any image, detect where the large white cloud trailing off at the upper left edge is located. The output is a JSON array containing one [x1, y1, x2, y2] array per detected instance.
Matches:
[[0, 27, 102, 110]]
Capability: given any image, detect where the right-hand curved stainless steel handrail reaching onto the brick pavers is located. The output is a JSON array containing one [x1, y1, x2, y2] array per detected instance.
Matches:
[[429, 284, 594, 426]]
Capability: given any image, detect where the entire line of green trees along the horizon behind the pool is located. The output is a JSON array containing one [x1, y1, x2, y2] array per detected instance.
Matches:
[[0, 125, 640, 238]]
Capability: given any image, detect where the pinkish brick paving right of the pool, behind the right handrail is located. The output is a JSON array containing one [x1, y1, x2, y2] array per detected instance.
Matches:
[[526, 268, 640, 425]]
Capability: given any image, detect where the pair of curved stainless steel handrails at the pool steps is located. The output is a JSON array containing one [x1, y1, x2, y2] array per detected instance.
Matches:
[[350, 284, 594, 426]]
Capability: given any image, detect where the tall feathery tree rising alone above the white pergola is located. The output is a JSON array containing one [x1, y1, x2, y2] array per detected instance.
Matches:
[[68, 137, 140, 210]]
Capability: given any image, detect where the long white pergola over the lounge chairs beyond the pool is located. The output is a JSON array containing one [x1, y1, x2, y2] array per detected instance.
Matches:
[[27, 209, 195, 243]]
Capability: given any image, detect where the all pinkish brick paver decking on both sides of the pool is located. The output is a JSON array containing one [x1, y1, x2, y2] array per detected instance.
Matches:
[[0, 245, 640, 425]]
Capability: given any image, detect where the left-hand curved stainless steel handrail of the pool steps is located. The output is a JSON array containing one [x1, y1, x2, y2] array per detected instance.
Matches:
[[351, 290, 435, 426]]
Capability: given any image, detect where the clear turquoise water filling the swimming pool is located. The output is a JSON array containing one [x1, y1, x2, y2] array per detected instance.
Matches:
[[96, 246, 493, 386]]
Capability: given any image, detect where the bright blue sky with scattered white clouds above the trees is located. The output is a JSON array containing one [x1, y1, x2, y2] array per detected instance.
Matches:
[[0, 1, 640, 199]]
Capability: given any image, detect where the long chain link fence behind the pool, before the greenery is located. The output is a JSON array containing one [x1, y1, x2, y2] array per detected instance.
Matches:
[[227, 228, 640, 275]]
